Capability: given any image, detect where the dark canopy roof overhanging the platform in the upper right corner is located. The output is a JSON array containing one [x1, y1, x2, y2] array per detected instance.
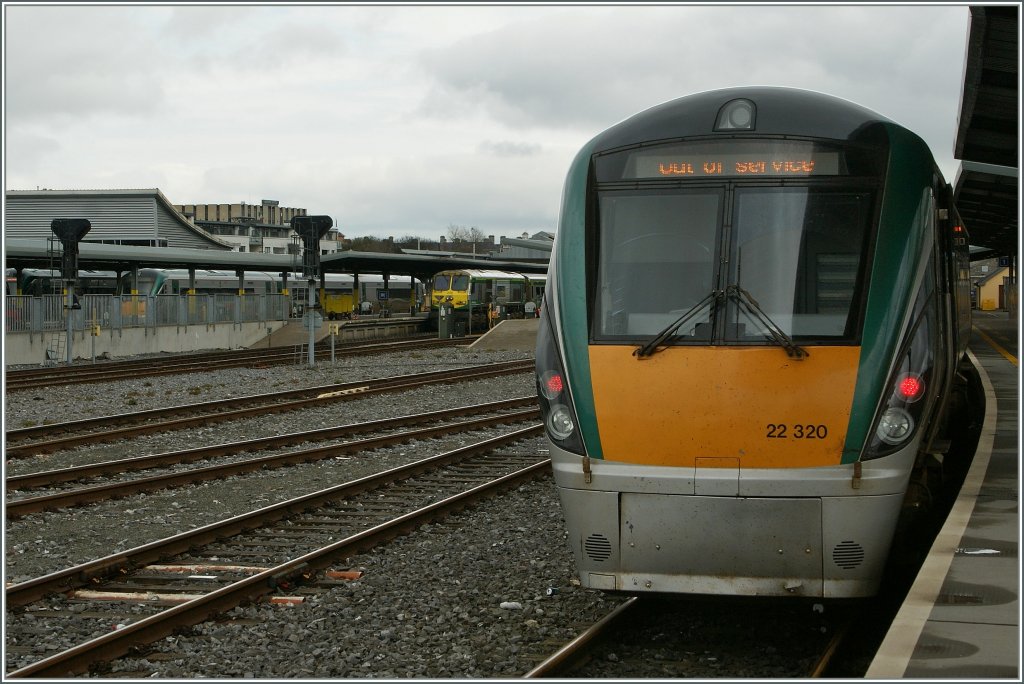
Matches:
[[953, 4, 1020, 256]]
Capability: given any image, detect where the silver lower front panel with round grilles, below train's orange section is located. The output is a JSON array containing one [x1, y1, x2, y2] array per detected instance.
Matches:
[[559, 486, 902, 598]]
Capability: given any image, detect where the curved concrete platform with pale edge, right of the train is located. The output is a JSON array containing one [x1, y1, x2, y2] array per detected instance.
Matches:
[[865, 316, 1021, 681]]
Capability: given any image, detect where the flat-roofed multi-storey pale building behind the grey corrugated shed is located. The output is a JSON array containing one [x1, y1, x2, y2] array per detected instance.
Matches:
[[174, 200, 344, 254]]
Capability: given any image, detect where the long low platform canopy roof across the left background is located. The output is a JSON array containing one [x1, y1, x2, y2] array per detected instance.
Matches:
[[4, 238, 548, 280]]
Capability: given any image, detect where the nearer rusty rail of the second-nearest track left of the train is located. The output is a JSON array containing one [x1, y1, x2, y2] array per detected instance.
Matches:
[[4, 408, 541, 519]]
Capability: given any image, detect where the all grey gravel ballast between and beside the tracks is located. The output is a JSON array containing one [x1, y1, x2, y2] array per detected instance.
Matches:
[[5, 349, 621, 679]]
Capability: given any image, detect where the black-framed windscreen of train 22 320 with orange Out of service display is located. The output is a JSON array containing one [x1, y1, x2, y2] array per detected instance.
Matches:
[[588, 139, 886, 345]]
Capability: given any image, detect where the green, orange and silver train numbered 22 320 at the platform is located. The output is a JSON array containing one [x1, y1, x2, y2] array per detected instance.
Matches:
[[537, 87, 971, 598]]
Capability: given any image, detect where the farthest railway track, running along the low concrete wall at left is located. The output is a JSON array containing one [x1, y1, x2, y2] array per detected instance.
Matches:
[[5, 336, 474, 392]]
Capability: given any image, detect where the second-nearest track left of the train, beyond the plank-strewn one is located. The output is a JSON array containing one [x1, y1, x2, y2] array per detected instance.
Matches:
[[5, 396, 540, 518]]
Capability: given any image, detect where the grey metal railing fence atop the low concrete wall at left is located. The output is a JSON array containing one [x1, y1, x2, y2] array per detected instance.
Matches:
[[4, 294, 289, 333]]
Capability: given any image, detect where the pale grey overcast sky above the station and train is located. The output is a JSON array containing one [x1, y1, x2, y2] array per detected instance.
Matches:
[[3, 4, 970, 240]]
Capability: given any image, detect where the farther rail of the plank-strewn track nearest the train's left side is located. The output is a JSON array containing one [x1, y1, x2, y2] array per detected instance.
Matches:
[[4, 424, 544, 607]]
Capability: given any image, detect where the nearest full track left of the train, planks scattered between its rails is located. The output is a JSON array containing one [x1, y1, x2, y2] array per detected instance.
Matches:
[[5, 424, 550, 678]]
